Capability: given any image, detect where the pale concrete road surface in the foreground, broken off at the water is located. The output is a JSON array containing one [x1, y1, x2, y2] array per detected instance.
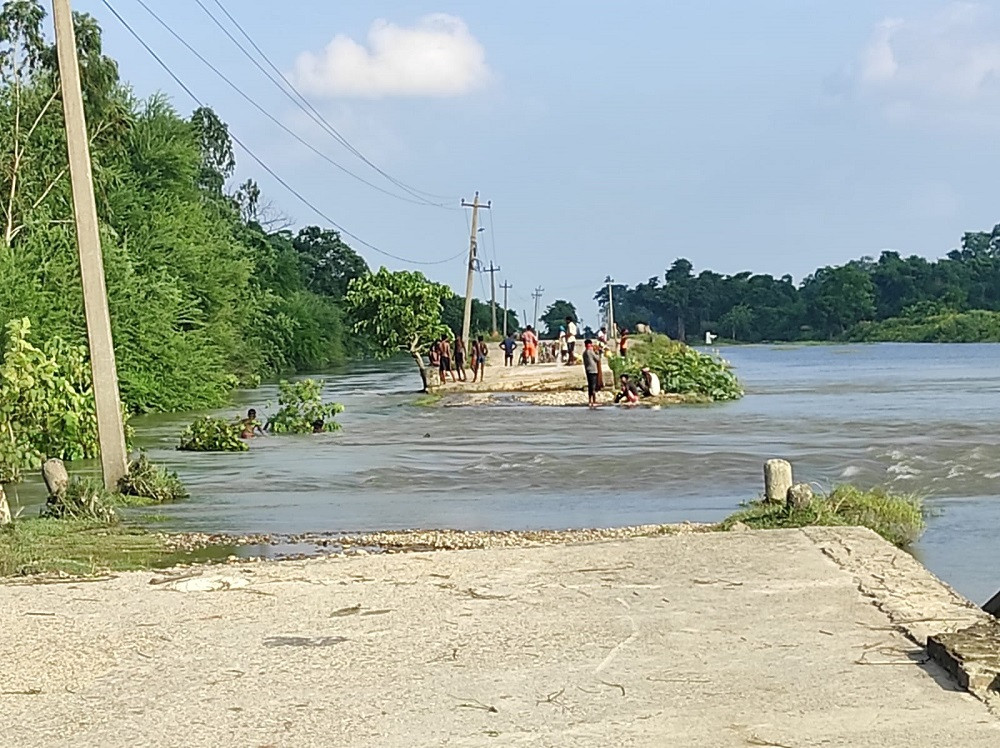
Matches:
[[0, 528, 1000, 748]]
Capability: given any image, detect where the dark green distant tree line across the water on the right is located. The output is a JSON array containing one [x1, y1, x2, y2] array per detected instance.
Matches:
[[594, 225, 1000, 342]]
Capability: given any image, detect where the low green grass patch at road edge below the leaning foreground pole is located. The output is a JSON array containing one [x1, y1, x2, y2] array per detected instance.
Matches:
[[0, 519, 232, 577]]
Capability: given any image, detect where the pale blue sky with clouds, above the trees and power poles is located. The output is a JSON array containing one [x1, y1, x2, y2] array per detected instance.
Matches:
[[73, 0, 1000, 326]]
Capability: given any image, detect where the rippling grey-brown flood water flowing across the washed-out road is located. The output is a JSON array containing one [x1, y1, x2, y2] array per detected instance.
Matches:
[[7, 344, 1000, 602]]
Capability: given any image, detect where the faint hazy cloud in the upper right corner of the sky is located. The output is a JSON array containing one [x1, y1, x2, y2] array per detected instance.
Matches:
[[857, 2, 1000, 103]]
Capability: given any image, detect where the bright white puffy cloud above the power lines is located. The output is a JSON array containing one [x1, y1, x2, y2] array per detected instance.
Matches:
[[294, 13, 492, 98]]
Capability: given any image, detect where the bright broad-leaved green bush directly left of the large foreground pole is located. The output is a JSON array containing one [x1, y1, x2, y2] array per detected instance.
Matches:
[[0, 318, 97, 483]]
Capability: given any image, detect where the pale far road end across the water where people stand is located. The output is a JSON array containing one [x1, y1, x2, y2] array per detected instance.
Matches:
[[433, 359, 703, 407]]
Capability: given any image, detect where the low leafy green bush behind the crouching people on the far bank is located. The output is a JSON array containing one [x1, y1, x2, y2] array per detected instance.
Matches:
[[610, 334, 743, 401]]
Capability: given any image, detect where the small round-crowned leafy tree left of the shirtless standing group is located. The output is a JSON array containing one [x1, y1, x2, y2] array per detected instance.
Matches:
[[345, 267, 454, 391]]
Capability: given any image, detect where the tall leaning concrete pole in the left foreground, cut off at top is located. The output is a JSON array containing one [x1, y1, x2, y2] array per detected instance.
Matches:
[[52, 0, 128, 490]]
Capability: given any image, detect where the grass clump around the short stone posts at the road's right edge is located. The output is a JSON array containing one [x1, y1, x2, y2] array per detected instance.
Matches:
[[719, 485, 926, 548]]
